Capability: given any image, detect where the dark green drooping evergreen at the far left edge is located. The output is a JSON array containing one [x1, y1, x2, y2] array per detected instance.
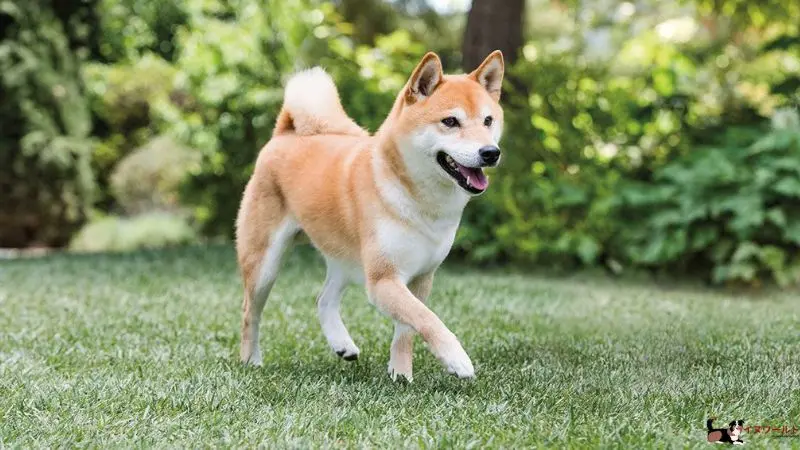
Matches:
[[0, 1, 95, 247]]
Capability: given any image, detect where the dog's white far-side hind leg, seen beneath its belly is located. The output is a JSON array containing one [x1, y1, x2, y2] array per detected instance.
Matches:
[[317, 260, 359, 361]]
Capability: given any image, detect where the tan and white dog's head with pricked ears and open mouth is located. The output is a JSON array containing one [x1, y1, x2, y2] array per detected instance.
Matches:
[[393, 51, 504, 195]]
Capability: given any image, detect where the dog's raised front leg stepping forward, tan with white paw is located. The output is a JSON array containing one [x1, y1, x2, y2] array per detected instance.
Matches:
[[368, 276, 475, 378]]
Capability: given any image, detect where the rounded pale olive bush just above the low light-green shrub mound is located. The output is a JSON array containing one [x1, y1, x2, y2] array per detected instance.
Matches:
[[111, 137, 200, 214]]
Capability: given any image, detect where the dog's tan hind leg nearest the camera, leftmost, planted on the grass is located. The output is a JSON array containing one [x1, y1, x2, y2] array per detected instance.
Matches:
[[241, 176, 298, 366]]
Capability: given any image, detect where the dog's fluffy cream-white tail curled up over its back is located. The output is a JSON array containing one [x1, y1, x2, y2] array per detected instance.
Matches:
[[272, 67, 368, 136]]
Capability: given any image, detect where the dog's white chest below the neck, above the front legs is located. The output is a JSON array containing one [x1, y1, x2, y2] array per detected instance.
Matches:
[[377, 218, 459, 282]]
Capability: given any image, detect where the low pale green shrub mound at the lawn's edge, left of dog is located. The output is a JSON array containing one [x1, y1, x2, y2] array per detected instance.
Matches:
[[70, 212, 199, 252]]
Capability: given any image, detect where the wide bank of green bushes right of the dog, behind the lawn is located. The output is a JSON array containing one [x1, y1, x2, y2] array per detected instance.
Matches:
[[456, 7, 800, 284]]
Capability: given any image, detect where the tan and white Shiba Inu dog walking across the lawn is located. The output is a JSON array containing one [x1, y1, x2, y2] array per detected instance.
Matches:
[[236, 51, 504, 380]]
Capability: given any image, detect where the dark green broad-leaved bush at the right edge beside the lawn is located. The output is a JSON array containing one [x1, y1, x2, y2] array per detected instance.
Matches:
[[618, 112, 800, 285]]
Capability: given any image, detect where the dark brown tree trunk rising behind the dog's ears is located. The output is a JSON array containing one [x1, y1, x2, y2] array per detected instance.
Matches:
[[461, 0, 525, 72]]
